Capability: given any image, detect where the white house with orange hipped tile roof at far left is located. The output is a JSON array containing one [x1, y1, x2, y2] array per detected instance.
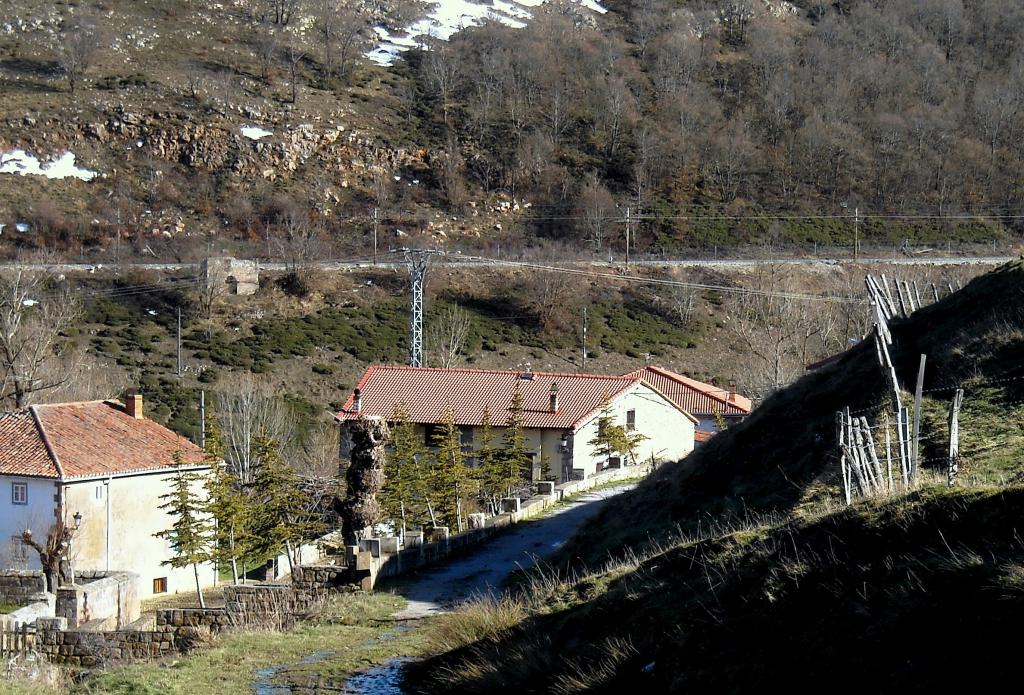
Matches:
[[0, 396, 216, 598]]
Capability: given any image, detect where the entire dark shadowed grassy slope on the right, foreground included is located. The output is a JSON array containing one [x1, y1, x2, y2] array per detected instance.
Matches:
[[410, 263, 1024, 693]]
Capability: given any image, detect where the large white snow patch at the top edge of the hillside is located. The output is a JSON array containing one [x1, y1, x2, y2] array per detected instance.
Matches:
[[366, 0, 607, 66]]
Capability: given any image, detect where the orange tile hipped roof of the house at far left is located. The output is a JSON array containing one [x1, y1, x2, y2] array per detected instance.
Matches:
[[0, 400, 203, 479]]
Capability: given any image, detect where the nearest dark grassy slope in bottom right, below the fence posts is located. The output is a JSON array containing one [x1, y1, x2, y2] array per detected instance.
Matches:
[[411, 486, 1024, 693]]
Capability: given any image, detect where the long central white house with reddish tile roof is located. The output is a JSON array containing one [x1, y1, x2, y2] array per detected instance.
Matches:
[[337, 365, 697, 482]]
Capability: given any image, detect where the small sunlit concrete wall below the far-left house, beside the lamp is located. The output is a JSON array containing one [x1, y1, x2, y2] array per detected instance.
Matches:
[[55, 572, 141, 629]]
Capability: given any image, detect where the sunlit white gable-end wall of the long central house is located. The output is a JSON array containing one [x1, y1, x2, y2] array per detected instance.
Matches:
[[572, 384, 695, 477]]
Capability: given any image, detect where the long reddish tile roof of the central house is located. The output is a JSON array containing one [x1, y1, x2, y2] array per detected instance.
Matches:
[[337, 365, 641, 430]]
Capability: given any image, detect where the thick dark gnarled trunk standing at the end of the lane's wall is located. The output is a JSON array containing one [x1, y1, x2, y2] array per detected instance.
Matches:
[[337, 418, 391, 545]]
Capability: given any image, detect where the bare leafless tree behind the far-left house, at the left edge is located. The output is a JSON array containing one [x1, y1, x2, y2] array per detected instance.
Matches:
[[0, 268, 79, 407]]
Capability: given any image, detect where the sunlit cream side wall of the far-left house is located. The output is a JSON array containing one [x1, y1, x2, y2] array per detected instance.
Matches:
[[65, 472, 216, 599]]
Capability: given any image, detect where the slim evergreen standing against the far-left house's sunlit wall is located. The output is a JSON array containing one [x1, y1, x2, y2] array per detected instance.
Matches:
[[154, 449, 213, 608]]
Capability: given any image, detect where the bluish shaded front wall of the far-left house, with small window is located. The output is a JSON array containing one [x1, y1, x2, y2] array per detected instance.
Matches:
[[0, 475, 57, 569]]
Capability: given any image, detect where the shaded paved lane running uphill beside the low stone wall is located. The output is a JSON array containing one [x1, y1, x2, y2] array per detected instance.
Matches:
[[386, 483, 635, 619]]
